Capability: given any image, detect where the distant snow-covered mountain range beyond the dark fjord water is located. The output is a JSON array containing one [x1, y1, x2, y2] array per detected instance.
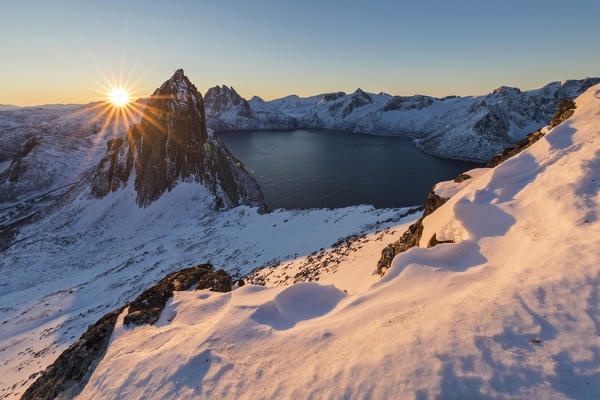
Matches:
[[207, 78, 600, 161]]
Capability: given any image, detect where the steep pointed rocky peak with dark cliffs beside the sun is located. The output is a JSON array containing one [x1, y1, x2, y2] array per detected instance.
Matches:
[[91, 70, 264, 208]]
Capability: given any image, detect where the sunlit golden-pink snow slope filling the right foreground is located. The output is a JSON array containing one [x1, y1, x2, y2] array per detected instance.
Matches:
[[79, 85, 600, 399]]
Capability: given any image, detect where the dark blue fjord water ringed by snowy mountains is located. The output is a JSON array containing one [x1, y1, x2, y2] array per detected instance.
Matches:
[[219, 129, 481, 209]]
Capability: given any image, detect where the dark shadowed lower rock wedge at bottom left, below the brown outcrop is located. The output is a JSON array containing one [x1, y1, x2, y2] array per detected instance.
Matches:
[[21, 307, 124, 400]]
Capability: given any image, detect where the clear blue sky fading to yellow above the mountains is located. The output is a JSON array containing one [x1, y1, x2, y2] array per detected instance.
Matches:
[[0, 0, 600, 105]]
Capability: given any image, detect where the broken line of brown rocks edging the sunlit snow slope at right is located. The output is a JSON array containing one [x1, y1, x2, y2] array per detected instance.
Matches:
[[377, 99, 575, 275]]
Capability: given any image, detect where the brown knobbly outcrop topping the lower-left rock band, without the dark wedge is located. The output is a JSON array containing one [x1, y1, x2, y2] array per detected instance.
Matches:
[[124, 264, 213, 325]]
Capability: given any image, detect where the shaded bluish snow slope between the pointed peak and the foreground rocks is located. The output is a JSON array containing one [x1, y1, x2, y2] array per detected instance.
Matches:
[[0, 190, 414, 399]]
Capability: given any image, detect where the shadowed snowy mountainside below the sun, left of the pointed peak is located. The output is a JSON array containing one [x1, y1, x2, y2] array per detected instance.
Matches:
[[0, 103, 138, 250]]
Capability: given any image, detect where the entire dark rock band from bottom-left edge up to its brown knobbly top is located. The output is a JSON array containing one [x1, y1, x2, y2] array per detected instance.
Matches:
[[21, 264, 231, 400]]
